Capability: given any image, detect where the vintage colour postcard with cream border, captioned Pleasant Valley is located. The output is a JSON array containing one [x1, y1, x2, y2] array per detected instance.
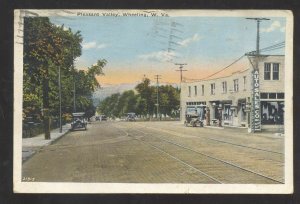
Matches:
[[13, 9, 293, 194]]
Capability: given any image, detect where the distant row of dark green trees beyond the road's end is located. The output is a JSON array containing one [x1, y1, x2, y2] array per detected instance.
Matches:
[[97, 78, 180, 117]]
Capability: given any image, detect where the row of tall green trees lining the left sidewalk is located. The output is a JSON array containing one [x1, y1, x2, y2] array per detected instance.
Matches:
[[23, 17, 107, 139]]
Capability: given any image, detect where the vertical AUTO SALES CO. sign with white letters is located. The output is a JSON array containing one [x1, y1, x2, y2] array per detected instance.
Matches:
[[252, 70, 261, 132]]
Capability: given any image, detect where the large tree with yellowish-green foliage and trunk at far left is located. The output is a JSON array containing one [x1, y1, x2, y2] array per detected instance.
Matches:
[[23, 17, 82, 139]]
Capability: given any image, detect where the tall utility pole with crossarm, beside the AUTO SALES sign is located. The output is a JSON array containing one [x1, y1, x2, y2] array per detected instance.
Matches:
[[246, 18, 270, 133]]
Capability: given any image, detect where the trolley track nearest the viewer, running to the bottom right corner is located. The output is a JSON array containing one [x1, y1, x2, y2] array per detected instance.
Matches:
[[114, 122, 283, 184]]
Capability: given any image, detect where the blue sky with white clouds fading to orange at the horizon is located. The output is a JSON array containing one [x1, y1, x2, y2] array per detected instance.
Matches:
[[50, 16, 286, 85]]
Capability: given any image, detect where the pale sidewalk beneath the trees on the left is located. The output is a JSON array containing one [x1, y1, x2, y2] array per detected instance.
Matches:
[[22, 124, 71, 162]]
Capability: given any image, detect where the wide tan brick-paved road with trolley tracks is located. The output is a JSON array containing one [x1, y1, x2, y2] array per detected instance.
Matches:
[[22, 122, 284, 183]]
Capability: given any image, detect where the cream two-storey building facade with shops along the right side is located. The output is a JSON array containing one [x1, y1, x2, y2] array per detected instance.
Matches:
[[180, 55, 284, 131]]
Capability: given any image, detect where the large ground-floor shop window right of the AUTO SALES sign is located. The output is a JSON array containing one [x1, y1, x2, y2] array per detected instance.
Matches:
[[261, 101, 284, 125]]
